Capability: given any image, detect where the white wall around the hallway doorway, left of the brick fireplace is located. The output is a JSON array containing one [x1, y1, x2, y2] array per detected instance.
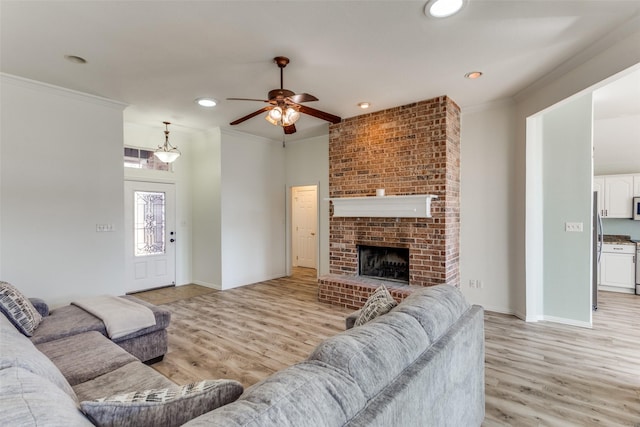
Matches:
[[284, 135, 329, 275]]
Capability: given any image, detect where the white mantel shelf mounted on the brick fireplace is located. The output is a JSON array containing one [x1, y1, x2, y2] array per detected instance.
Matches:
[[328, 194, 438, 218]]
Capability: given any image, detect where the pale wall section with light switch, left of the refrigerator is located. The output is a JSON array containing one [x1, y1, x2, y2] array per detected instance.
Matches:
[[540, 94, 593, 327]]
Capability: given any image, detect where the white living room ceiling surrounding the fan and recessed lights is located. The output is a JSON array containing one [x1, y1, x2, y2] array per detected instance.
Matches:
[[0, 0, 640, 138]]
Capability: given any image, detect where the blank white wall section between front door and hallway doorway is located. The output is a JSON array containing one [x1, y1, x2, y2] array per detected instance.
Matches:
[[221, 131, 286, 289]]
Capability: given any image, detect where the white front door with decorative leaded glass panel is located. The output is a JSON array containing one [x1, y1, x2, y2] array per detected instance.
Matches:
[[124, 181, 176, 292]]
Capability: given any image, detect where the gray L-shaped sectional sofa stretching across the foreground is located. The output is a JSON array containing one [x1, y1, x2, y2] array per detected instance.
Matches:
[[0, 285, 484, 427]]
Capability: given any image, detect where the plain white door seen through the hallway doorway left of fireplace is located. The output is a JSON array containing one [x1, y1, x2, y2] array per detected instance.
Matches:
[[291, 185, 318, 268]]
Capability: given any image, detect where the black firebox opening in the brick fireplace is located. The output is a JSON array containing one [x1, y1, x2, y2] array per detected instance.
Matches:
[[358, 245, 409, 285]]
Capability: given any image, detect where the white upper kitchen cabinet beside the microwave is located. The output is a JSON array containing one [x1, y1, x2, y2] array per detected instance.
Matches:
[[593, 175, 640, 218]]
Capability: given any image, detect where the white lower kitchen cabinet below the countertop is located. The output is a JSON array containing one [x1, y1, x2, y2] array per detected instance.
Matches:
[[600, 243, 636, 293]]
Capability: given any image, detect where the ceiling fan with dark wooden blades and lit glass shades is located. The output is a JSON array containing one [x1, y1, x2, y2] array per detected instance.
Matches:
[[227, 56, 342, 135]]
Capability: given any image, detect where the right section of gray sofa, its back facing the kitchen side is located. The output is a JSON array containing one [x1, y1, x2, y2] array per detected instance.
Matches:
[[185, 285, 485, 427]]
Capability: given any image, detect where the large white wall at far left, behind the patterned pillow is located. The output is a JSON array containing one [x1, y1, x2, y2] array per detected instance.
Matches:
[[0, 75, 124, 306]]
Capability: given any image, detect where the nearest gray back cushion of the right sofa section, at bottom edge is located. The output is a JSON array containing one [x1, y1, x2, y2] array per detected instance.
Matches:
[[185, 362, 366, 427]]
